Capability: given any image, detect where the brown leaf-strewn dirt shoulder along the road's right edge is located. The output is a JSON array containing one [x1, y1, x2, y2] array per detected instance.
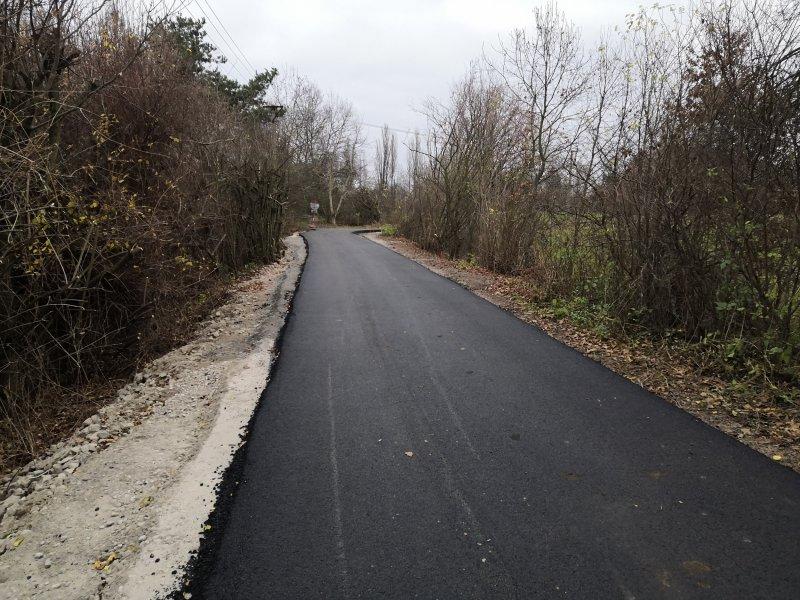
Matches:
[[364, 233, 800, 472]]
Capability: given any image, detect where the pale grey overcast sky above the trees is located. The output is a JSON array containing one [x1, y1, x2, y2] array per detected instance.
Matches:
[[187, 0, 680, 162]]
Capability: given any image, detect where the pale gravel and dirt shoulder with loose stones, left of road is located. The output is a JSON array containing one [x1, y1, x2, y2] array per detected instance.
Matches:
[[0, 235, 306, 600]]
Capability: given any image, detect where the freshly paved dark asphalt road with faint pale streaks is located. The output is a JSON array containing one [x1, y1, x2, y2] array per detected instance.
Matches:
[[195, 230, 800, 600]]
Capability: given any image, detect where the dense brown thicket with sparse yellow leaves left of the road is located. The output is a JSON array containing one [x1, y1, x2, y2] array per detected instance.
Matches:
[[0, 0, 290, 470]]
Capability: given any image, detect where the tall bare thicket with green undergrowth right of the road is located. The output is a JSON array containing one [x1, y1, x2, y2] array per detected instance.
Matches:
[[401, 1, 800, 392]]
